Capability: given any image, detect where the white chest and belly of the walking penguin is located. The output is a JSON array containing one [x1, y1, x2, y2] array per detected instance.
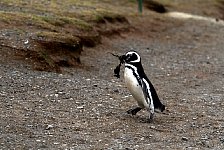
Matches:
[[124, 67, 148, 108]]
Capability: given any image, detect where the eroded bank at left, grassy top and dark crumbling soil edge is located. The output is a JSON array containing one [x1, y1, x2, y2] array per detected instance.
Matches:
[[0, 0, 134, 72]]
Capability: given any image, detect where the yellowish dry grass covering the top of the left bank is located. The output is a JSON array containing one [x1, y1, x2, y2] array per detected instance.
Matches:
[[0, 0, 137, 41]]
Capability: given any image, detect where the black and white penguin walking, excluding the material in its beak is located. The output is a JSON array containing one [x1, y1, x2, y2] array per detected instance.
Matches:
[[120, 51, 165, 121]]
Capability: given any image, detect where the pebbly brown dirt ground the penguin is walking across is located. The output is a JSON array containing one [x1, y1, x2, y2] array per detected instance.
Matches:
[[0, 0, 224, 150]]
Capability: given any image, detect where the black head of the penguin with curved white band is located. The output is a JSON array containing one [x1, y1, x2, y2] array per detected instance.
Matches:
[[121, 51, 141, 64]]
